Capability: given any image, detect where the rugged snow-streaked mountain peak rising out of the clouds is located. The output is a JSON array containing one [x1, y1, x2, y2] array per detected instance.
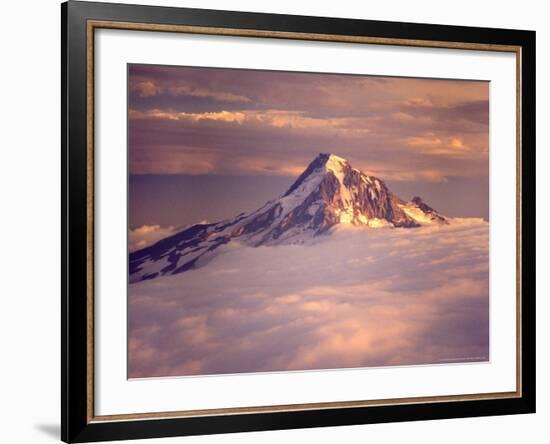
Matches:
[[129, 154, 448, 283]]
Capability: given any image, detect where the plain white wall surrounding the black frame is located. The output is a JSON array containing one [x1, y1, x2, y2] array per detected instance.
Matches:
[[0, 0, 550, 444]]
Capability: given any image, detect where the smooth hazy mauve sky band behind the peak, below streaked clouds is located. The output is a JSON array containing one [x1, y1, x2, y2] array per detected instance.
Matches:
[[129, 171, 489, 230]]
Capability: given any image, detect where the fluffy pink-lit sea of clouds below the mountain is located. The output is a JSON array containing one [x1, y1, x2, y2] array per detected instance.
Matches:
[[128, 219, 489, 378]]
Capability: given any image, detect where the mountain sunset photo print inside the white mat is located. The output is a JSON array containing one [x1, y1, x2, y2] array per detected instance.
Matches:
[[128, 64, 490, 378]]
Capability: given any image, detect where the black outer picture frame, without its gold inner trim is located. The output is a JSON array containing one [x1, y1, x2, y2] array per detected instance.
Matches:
[[61, 1, 536, 442]]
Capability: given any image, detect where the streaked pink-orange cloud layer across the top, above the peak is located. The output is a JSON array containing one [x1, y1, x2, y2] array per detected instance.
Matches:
[[129, 65, 489, 182]]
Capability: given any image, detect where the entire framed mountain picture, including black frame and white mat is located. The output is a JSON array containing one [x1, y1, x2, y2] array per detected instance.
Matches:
[[61, 1, 535, 442]]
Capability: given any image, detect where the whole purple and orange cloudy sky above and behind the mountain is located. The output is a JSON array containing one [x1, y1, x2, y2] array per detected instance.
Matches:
[[128, 64, 489, 233]]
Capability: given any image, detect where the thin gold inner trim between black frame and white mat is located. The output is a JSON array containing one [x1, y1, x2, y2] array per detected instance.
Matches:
[[86, 20, 522, 423]]
